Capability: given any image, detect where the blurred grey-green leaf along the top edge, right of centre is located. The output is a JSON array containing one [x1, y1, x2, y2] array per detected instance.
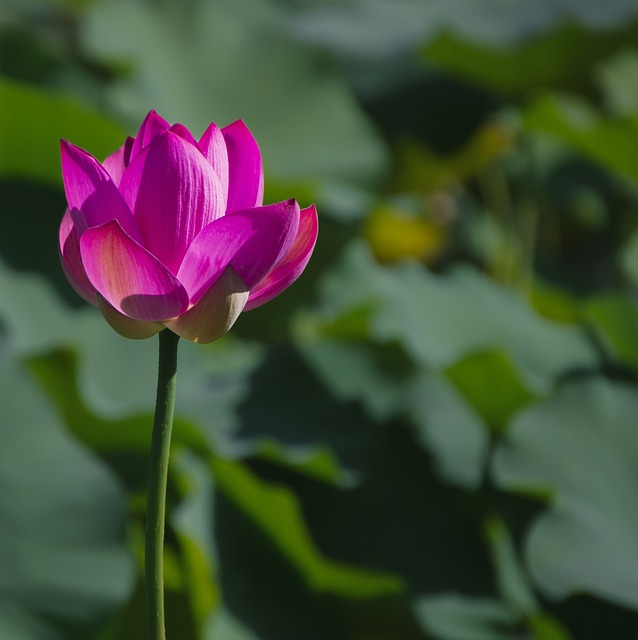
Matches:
[[295, 0, 636, 58]]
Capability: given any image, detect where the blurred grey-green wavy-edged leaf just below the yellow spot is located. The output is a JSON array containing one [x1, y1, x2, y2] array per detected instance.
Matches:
[[322, 243, 596, 391]]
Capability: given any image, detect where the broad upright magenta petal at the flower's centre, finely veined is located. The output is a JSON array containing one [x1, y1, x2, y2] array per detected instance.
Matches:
[[120, 131, 224, 273]]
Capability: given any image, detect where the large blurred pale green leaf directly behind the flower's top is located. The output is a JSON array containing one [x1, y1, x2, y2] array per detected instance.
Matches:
[[83, 0, 385, 192]]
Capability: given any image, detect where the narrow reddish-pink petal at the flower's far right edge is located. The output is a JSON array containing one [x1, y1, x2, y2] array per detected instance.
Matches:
[[244, 205, 319, 311]]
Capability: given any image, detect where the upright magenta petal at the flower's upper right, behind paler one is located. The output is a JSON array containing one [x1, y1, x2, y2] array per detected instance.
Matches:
[[222, 120, 264, 213]]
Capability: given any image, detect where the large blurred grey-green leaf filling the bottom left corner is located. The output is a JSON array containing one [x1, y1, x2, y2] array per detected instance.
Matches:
[[0, 355, 132, 640]]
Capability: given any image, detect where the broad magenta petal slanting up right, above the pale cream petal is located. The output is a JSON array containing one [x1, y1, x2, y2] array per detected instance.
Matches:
[[178, 200, 299, 304]]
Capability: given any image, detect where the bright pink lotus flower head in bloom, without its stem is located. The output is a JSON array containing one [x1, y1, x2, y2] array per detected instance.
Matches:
[[59, 111, 317, 342]]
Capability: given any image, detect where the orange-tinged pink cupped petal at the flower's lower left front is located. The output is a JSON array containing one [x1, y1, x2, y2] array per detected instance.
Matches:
[[80, 221, 188, 322]]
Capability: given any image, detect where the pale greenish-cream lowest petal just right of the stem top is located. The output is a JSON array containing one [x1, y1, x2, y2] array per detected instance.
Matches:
[[166, 267, 248, 344]]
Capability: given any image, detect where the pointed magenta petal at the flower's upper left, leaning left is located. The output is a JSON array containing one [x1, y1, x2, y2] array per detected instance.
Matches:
[[60, 140, 140, 239]]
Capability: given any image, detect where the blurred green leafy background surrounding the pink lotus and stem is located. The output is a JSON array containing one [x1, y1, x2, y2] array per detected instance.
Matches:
[[0, 0, 638, 640]]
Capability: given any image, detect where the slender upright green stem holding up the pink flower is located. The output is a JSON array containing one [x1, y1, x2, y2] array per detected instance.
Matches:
[[145, 329, 179, 640]]
